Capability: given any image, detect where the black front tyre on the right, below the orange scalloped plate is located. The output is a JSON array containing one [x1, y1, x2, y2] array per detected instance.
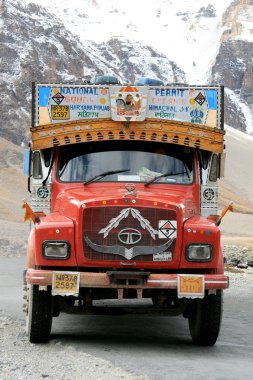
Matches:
[[188, 291, 222, 346]]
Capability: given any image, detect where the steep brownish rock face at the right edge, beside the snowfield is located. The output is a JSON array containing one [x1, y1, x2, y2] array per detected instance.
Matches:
[[212, 0, 253, 132]]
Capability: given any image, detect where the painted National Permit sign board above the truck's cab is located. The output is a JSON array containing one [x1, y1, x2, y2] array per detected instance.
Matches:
[[33, 84, 223, 129]]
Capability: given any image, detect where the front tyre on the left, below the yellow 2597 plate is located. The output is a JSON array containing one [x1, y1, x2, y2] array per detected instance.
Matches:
[[26, 285, 53, 343]]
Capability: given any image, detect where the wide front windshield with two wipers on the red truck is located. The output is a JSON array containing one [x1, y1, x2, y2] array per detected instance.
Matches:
[[58, 141, 194, 185]]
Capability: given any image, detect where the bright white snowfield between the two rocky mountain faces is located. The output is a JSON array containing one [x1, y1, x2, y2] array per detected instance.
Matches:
[[21, 0, 232, 84]]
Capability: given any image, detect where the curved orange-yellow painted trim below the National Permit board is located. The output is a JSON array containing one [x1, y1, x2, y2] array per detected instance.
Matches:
[[31, 119, 225, 153]]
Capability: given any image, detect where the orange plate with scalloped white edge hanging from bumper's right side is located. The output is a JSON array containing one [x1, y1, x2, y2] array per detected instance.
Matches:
[[177, 274, 205, 298]]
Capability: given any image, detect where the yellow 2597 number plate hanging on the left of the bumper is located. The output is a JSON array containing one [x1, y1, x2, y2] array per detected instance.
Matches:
[[52, 272, 80, 296]]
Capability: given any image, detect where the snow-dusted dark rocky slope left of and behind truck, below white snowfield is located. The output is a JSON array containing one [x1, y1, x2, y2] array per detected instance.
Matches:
[[0, 0, 185, 144]]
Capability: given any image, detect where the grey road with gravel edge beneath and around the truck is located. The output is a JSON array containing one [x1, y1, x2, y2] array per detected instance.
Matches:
[[0, 257, 253, 380]]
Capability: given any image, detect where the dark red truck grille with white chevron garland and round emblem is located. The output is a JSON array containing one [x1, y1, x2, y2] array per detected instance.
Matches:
[[83, 206, 177, 261]]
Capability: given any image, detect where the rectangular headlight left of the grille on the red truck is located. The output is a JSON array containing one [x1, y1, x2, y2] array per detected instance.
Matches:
[[42, 240, 70, 259]]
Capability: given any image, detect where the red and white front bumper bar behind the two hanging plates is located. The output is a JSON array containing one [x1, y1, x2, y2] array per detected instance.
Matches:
[[26, 269, 229, 290]]
